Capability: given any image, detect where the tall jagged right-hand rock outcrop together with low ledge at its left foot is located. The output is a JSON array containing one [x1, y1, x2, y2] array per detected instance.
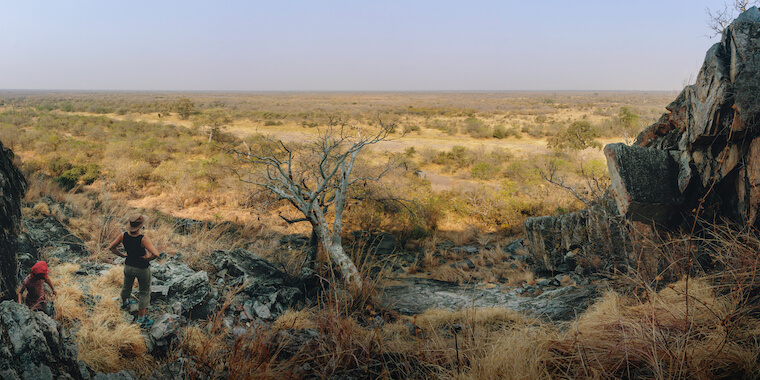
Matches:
[[525, 7, 760, 271]]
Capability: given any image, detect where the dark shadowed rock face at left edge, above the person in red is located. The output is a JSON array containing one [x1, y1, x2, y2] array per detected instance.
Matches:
[[0, 142, 26, 300]]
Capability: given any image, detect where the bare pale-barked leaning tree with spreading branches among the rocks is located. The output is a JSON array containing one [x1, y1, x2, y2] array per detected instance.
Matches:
[[233, 120, 395, 287]]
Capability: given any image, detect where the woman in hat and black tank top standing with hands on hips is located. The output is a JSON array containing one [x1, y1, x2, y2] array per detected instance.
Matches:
[[108, 214, 159, 327]]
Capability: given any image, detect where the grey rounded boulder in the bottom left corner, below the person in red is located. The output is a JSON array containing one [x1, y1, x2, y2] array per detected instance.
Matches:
[[0, 301, 89, 380]]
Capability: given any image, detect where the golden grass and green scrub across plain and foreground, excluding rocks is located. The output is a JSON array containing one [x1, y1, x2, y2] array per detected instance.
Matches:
[[5, 93, 760, 379]]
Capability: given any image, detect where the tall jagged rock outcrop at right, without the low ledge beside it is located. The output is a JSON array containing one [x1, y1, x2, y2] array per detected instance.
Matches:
[[616, 7, 760, 226]]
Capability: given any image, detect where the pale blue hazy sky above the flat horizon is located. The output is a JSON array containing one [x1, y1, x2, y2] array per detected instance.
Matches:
[[0, 0, 740, 91]]
